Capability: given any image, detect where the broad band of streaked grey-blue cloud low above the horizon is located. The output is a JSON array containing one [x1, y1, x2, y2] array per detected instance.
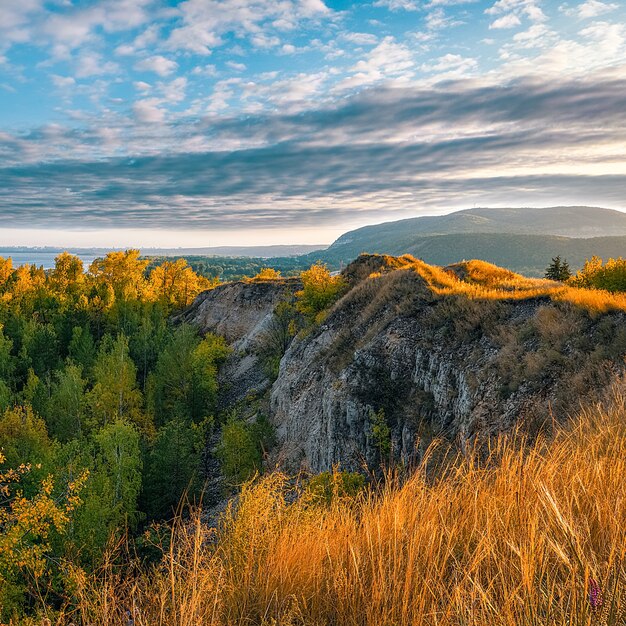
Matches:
[[0, 69, 626, 229]]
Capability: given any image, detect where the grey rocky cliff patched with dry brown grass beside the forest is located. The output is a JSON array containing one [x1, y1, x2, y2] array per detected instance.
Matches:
[[187, 256, 626, 471]]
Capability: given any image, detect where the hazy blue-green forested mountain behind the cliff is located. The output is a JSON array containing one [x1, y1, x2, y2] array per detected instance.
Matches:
[[308, 207, 626, 275]]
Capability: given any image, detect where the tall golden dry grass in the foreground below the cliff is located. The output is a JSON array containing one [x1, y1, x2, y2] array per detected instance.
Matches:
[[62, 393, 626, 626]]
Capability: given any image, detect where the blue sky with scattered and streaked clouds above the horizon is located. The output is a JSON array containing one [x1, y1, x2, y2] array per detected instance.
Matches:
[[0, 0, 626, 247]]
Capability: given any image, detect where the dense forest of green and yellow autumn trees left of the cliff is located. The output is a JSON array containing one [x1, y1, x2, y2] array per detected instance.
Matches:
[[0, 251, 229, 623]]
